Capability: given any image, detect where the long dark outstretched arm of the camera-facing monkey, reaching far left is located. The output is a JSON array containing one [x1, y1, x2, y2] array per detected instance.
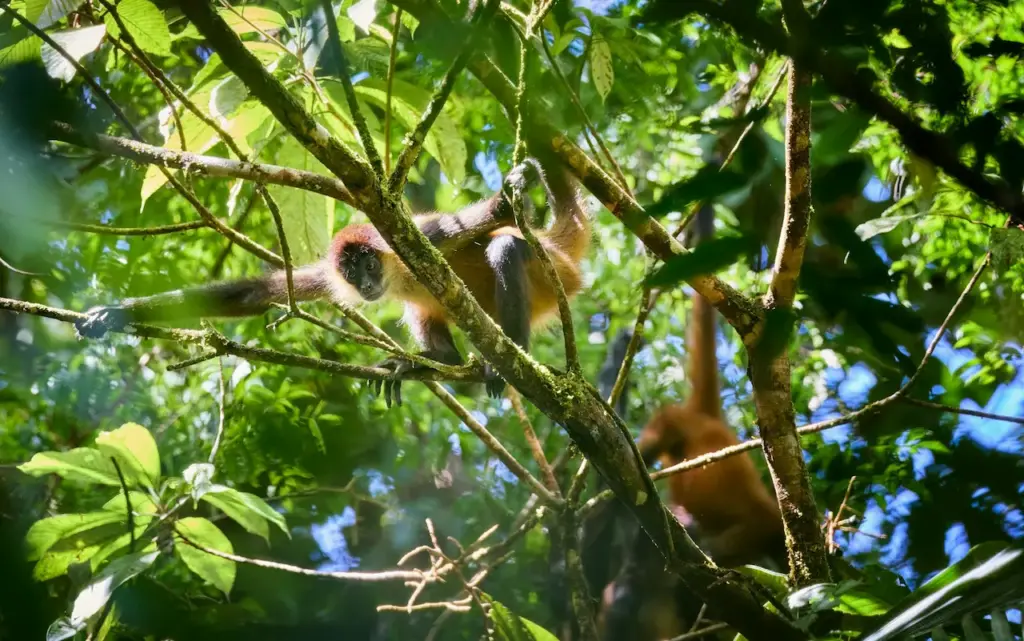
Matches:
[[75, 264, 330, 338]]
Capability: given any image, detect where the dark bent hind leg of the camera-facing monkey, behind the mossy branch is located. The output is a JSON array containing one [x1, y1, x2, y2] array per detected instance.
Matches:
[[483, 236, 530, 398]]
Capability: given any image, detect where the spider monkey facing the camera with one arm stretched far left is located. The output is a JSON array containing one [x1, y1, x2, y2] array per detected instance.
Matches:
[[76, 158, 590, 407]]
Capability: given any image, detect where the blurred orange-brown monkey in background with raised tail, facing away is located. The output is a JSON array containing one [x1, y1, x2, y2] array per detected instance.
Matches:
[[638, 201, 787, 568]]
